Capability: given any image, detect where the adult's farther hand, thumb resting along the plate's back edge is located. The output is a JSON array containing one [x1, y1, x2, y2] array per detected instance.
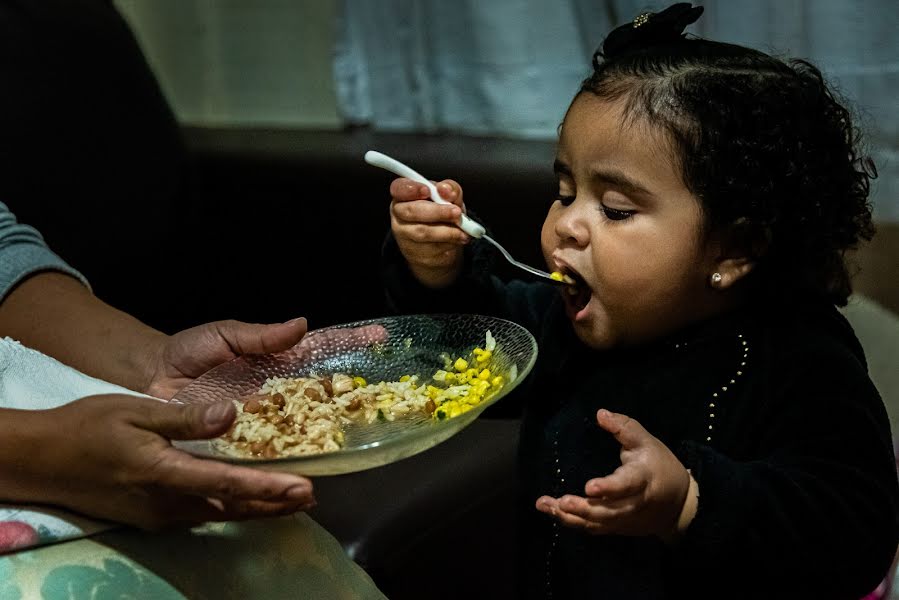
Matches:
[[145, 318, 306, 400]]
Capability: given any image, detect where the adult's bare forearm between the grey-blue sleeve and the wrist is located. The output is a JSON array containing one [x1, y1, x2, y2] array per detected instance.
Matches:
[[0, 272, 166, 391]]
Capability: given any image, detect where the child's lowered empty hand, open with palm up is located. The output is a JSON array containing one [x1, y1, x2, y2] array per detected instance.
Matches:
[[537, 409, 690, 539]]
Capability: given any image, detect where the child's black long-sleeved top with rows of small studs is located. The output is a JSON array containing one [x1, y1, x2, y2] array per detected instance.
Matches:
[[384, 239, 899, 599]]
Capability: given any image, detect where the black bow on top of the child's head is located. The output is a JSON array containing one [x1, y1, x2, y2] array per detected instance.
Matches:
[[593, 2, 703, 68]]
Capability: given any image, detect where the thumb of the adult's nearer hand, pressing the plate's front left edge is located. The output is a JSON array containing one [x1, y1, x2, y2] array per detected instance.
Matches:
[[137, 400, 236, 440]]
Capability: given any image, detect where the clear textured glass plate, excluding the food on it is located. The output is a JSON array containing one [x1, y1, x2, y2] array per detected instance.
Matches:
[[172, 315, 537, 476]]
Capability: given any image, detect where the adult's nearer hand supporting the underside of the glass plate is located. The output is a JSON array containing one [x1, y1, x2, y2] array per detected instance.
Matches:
[[10, 395, 315, 529]]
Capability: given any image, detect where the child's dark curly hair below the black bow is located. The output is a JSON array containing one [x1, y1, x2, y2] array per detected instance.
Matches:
[[579, 38, 877, 306]]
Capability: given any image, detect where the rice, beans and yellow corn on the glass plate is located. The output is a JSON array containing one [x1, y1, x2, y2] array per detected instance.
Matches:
[[212, 331, 506, 458]]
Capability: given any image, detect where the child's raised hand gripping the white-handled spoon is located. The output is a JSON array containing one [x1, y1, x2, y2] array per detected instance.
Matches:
[[390, 178, 471, 288]]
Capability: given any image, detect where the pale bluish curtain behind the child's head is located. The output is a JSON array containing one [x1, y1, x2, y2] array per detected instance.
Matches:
[[334, 0, 899, 222]]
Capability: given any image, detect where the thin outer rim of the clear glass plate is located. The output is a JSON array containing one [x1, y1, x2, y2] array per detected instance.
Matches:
[[172, 313, 538, 467]]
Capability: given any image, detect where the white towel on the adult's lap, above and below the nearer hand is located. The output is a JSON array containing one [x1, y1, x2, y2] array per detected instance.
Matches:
[[0, 338, 149, 552]]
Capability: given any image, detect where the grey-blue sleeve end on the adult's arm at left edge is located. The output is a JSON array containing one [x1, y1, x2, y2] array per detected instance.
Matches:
[[0, 202, 90, 302]]
